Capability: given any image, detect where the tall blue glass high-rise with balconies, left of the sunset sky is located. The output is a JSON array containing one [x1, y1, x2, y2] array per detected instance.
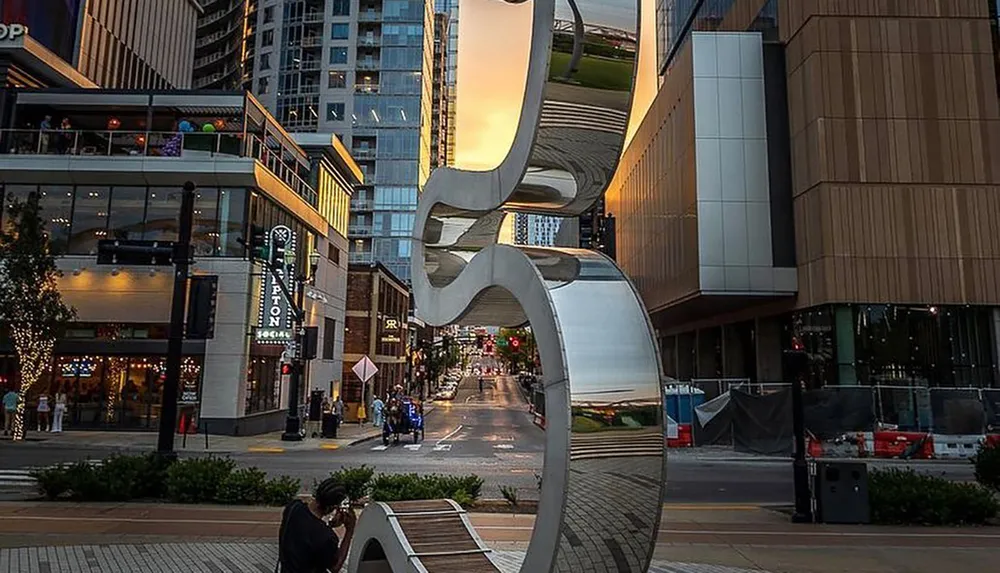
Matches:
[[247, 0, 434, 281]]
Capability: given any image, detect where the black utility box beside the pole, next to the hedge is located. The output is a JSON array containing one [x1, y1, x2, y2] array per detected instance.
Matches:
[[813, 462, 871, 524]]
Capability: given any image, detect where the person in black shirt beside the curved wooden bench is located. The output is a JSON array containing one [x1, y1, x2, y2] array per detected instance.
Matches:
[[276, 478, 357, 573]]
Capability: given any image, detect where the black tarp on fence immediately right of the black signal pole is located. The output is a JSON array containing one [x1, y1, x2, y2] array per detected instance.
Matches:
[[802, 386, 875, 440]]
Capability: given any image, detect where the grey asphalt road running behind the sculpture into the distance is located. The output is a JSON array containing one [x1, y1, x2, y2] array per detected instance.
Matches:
[[0, 370, 973, 504]]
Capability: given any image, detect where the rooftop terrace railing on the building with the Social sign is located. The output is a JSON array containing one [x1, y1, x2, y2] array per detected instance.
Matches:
[[0, 129, 319, 206]]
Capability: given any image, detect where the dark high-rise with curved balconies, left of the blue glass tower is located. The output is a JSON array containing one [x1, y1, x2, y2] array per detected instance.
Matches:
[[192, 0, 252, 90]]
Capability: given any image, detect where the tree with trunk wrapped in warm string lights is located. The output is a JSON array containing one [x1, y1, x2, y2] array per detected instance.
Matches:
[[0, 192, 76, 440]]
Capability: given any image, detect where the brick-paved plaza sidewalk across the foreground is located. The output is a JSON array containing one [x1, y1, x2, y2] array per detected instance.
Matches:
[[0, 502, 1000, 573]]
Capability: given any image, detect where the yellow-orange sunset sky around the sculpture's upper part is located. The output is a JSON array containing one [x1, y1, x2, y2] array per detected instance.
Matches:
[[455, 0, 657, 170]]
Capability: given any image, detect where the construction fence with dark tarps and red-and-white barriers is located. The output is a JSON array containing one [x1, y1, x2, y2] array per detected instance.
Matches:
[[664, 380, 1000, 458]]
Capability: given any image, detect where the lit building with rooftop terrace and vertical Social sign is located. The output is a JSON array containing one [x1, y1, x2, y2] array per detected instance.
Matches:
[[0, 90, 361, 435]]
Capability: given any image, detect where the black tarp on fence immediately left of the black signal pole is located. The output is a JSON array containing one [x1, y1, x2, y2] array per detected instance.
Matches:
[[729, 389, 792, 455]]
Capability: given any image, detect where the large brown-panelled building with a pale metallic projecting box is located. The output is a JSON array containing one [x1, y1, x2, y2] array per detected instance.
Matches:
[[607, 0, 1000, 386]]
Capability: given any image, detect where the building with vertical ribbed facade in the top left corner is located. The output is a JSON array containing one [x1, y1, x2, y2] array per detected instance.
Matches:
[[0, 0, 202, 89]]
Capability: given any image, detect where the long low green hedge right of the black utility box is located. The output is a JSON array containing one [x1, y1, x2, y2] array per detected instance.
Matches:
[[868, 469, 1000, 525]]
